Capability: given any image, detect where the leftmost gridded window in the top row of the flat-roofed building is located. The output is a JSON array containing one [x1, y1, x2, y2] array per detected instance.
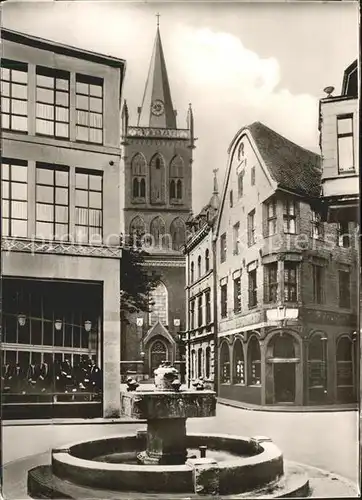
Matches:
[[1, 59, 28, 132]]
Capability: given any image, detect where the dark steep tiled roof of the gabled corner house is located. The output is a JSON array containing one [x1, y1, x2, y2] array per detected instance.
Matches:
[[249, 122, 321, 196]]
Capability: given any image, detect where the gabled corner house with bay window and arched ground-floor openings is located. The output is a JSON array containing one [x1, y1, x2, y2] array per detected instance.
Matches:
[[215, 122, 358, 405]]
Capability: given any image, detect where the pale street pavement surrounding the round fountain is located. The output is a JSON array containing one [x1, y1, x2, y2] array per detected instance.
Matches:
[[3, 405, 359, 498]]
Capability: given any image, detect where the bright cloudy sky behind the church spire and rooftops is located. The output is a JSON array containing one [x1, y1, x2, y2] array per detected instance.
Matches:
[[1, 0, 358, 214]]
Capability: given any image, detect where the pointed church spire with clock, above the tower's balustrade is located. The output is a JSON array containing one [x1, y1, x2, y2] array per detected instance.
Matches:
[[138, 18, 176, 128]]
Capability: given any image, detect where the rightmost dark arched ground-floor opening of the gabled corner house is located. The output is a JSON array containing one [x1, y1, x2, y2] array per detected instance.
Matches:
[[336, 336, 355, 403]]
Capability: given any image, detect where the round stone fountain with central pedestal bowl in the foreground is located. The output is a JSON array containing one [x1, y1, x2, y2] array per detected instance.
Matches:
[[28, 362, 309, 500]]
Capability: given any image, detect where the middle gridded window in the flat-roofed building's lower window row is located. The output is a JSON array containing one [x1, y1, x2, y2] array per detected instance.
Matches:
[[36, 163, 69, 241]]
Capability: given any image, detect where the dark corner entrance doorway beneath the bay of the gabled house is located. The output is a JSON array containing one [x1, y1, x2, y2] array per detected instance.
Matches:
[[272, 334, 296, 403]]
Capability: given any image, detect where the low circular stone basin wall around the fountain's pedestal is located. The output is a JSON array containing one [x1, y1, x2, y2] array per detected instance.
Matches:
[[52, 431, 283, 495]]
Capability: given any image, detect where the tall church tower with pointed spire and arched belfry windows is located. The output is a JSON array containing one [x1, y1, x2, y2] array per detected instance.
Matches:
[[121, 16, 195, 376]]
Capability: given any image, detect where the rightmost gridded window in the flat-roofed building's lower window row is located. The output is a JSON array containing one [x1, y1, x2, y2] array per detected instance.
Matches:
[[75, 169, 103, 243]]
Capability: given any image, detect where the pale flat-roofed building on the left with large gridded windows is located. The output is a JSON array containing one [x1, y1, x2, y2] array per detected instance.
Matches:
[[1, 29, 125, 416]]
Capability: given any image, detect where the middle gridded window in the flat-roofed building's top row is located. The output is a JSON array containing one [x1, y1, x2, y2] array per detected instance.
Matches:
[[36, 67, 69, 139]]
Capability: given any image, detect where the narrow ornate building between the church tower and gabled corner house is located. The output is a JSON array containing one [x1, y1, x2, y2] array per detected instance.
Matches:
[[184, 170, 220, 387]]
